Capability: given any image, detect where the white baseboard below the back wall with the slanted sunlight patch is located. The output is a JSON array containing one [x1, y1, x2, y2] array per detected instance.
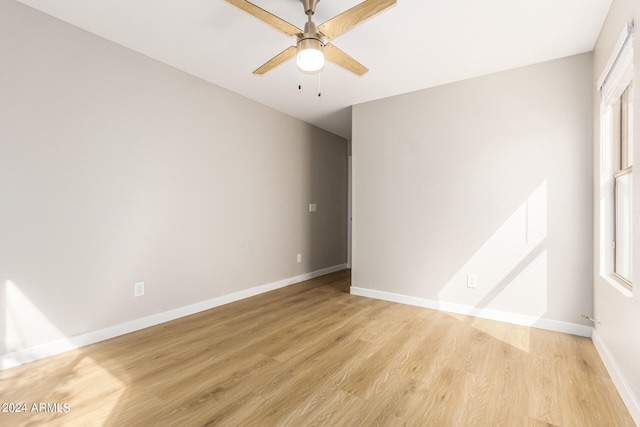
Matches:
[[350, 286, 592, 337]]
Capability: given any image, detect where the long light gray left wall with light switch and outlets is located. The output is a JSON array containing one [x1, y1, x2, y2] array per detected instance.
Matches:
[[0, 0, 347, 354]]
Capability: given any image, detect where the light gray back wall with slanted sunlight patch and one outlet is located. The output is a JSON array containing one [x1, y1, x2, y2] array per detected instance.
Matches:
[[352, 54, 592, 330]]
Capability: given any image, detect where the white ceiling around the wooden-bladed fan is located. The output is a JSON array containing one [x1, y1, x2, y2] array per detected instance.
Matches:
[[18, 0, 611, 138]]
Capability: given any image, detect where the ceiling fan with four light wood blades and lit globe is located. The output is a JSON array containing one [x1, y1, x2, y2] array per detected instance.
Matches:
[[225, 0, 396, 76]]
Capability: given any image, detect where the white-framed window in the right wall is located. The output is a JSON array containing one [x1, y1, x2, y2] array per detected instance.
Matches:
[[600, 24, 633, 287]]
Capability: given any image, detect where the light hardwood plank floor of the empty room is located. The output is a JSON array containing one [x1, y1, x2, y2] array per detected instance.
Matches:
[[0, 270, 635, 426]]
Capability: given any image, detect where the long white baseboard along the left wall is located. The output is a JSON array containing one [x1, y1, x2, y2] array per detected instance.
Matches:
[[0, 264, 347, 370]]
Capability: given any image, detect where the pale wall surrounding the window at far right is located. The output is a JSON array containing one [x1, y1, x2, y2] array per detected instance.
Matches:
[[592, 0, 640, 424]]
